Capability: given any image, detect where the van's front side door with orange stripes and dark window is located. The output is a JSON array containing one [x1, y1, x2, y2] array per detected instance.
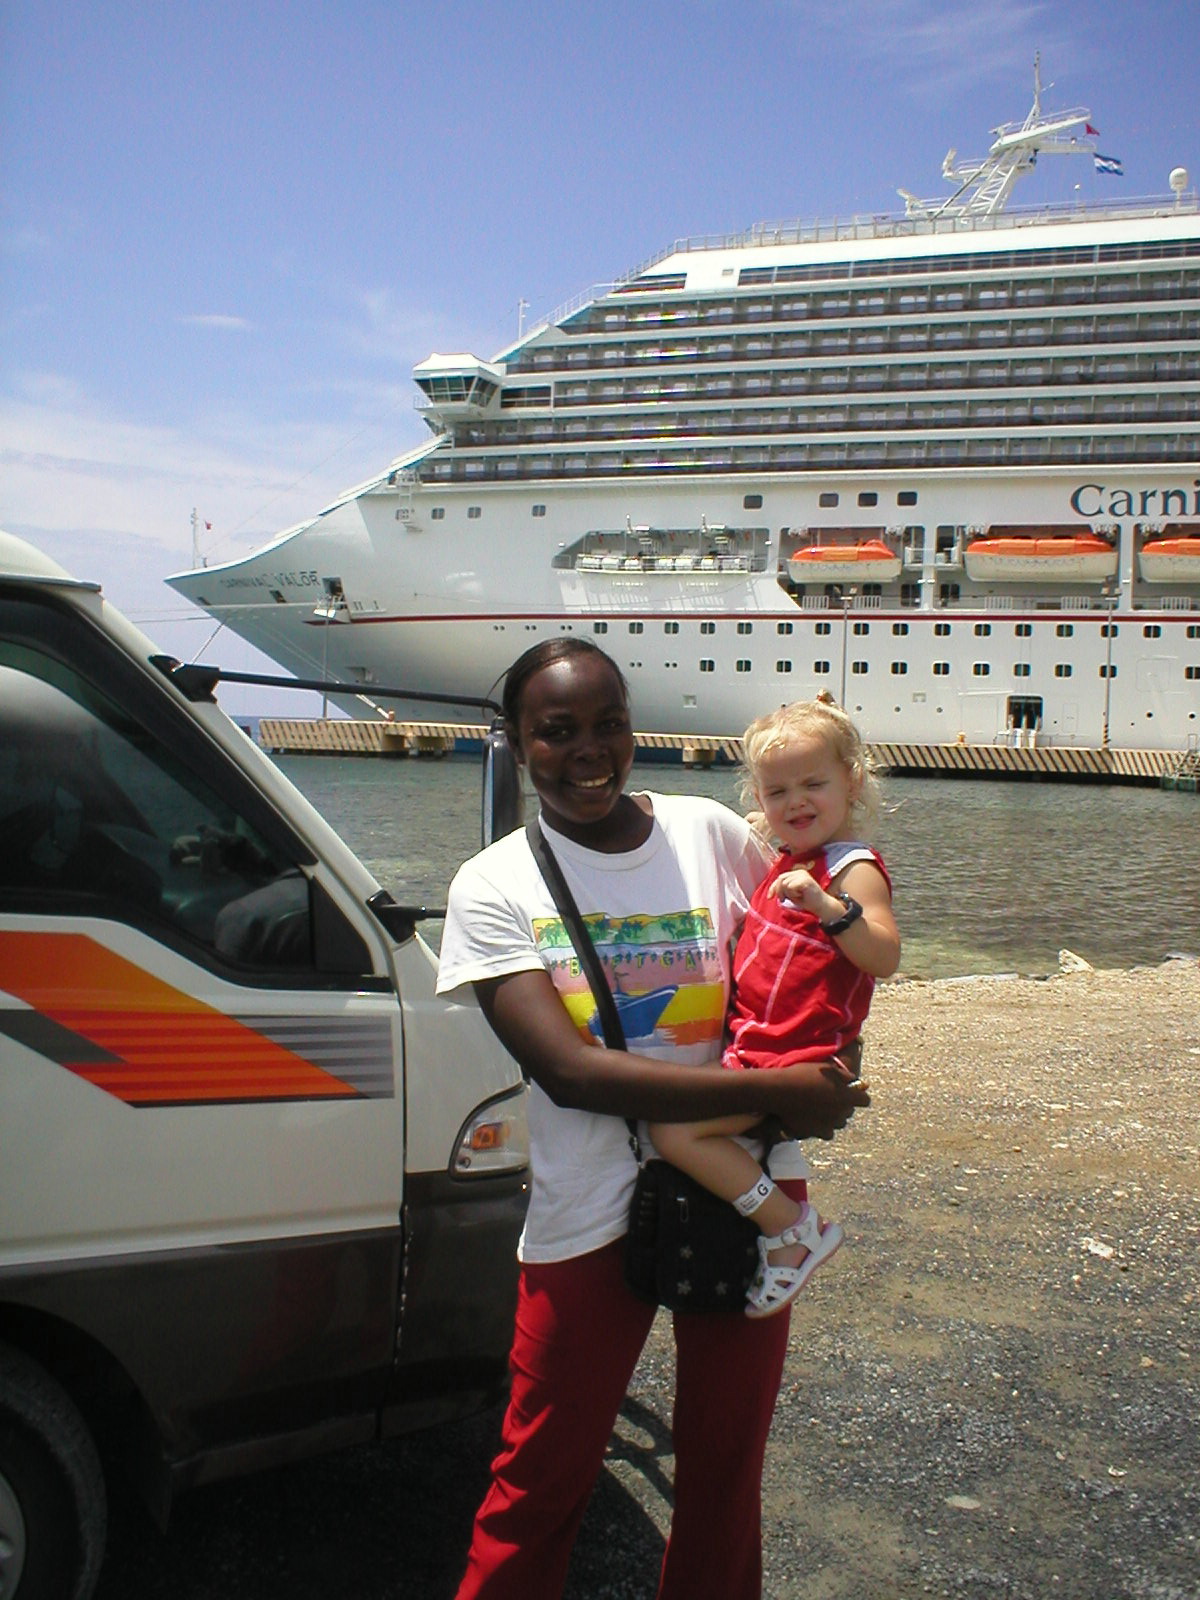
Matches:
[[0, 586, 405, 1482]]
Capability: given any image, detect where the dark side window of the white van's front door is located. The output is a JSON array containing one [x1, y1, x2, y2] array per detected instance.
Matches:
[[0, 602, 370, 979]]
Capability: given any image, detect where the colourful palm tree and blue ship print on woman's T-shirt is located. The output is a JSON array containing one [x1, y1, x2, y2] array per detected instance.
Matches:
[[533, 906, 725, 1051]]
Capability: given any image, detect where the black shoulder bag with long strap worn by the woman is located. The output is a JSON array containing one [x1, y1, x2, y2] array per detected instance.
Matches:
[[525, 818, 758, 1312]]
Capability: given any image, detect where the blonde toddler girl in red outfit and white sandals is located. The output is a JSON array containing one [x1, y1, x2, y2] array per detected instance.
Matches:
[[650, 699, 901, 1317]]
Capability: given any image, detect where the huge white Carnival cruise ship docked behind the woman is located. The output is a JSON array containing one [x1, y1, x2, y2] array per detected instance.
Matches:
[[168, 70, 1200, 752]]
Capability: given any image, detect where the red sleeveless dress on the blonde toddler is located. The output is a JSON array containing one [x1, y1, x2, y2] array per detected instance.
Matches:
[[723, 840, 891, 1069]]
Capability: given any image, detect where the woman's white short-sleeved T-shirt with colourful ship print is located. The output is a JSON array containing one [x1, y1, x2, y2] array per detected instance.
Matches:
[[437, 794, 770, 1261]]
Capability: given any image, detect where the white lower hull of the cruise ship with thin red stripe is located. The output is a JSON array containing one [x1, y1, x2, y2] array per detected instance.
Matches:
[[171, 475, 1200, 749]]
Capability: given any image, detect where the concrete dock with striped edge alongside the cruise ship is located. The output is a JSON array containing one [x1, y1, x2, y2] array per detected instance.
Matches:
[[258, 717, 1200, 792]]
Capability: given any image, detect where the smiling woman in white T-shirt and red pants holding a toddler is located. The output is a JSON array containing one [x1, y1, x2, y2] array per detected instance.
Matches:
[[438, 637, 866, 1600]]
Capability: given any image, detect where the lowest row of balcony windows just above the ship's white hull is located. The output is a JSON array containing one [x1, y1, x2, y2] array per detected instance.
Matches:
[[421, 432, 1197, 483]]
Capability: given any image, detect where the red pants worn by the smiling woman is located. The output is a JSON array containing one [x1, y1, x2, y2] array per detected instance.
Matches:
[[458, 1184, 803, 1600]]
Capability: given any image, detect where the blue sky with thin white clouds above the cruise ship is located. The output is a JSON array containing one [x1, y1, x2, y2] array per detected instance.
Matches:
[[0, 0, 1200, 709]]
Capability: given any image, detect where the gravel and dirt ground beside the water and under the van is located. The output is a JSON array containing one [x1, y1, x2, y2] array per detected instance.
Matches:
[[98, 958, 1200, 1600]]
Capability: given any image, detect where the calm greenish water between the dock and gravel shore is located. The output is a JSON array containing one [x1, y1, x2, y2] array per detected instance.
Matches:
[[277, 755, 1200, 978]]
